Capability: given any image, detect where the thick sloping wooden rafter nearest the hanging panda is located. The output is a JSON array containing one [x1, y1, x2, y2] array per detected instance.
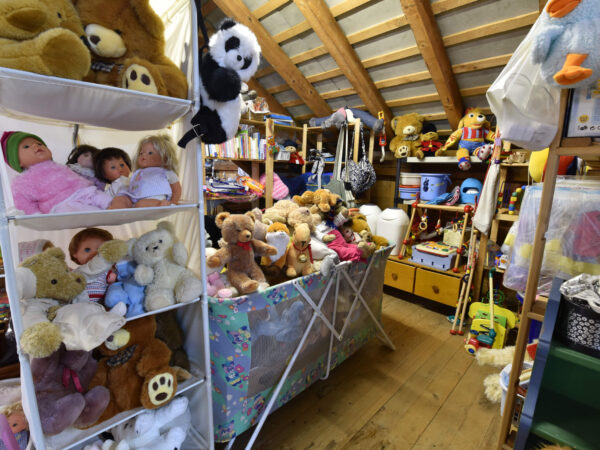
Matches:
[[214, 0, 331, 116]]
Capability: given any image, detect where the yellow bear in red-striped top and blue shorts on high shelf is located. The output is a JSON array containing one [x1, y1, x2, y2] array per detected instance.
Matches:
[[436, 108, 496, 170]]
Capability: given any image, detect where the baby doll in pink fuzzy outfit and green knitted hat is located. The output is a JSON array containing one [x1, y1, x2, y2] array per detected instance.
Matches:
[[0, 131, 120, 214]]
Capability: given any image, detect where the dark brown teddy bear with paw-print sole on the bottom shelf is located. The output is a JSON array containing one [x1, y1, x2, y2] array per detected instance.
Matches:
[[90, 316, 177, 422]]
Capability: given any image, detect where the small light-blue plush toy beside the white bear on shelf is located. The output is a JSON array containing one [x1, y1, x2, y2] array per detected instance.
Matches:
[[104, 259, 146, 317]]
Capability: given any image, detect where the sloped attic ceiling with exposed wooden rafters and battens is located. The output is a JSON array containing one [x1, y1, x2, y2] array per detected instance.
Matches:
[[202, 0, 544, 134]]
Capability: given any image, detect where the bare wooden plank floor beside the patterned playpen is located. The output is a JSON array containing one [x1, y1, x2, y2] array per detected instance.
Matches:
[[227, 291, 500, 450]]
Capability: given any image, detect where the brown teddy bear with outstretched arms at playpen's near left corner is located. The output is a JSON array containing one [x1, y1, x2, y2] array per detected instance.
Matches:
[[206, 212, 277, 294]]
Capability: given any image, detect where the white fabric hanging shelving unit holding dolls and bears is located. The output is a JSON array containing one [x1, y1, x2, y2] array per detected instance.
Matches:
[[0, 0, 214, 450]]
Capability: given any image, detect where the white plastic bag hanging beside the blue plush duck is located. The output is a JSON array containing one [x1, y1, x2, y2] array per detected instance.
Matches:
[[486, 14, 560, 150]]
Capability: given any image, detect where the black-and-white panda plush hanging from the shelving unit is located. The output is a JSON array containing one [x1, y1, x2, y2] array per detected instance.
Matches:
[[178, 18, 260, 148]]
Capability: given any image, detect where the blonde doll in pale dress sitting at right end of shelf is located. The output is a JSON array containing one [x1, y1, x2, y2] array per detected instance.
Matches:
[[127, 134, 181, 208]]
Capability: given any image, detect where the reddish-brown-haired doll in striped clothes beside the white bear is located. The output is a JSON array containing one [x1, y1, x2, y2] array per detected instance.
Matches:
[[69, 228, 117, 303]]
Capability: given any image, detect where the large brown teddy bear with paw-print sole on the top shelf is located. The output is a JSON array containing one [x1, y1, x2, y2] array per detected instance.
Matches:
[[73, 0, 188, 98]]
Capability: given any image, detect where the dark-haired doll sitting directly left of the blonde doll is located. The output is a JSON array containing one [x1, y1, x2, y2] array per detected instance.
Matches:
[[94, 147, 131, 208]]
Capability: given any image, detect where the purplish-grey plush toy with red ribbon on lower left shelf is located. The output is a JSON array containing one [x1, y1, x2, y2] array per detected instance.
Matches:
[[31, 345, 110, 435]]
